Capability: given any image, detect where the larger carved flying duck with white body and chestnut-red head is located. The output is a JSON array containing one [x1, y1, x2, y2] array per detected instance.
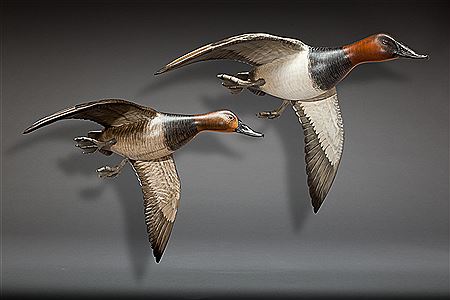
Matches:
[[155, 33, 428, 213]]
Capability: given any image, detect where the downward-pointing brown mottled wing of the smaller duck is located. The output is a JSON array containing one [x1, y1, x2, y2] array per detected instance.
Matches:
[[131, 155, 181, 262]]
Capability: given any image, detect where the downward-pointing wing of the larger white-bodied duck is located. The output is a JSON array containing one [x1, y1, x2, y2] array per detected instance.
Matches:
[[293, 90, 344, 213]]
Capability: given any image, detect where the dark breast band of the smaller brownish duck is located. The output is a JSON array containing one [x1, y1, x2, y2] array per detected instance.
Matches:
[[164, 114, 199, 151]]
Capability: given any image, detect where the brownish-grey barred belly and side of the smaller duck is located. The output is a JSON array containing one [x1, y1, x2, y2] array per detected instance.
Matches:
[[103, 122, 173, 160]]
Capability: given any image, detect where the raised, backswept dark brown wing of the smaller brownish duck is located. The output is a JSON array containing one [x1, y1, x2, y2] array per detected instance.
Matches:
[[23, 99, 156, 133]]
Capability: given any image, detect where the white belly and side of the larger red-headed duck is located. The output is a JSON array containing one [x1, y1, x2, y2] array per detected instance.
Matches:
[[254, 50, 323, 100]]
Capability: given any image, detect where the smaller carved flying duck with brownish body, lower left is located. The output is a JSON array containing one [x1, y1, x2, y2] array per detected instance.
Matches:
[[23, 99, 263, 262]]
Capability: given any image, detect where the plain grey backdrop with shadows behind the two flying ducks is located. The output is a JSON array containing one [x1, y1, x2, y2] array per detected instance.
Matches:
[[1, 1, 449, 297]]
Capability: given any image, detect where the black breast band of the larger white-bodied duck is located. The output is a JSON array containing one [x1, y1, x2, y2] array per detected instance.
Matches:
[[308, 47, 352, 91]]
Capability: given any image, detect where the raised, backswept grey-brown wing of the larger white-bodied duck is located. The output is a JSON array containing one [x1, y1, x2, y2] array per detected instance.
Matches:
[[155, 33, 305, 74]]
